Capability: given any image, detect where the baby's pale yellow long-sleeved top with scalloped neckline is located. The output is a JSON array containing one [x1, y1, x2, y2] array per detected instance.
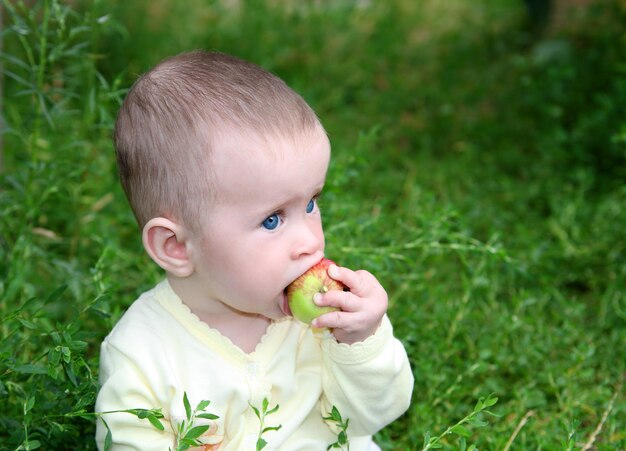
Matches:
[[96, 281, 413, 451]]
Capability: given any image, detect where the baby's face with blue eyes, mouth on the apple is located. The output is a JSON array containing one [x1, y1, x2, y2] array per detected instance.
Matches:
[[192, 129, 330, 319]]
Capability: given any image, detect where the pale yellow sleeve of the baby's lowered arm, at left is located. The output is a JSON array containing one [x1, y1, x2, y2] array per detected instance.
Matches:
[[96, 341, 174, 451]]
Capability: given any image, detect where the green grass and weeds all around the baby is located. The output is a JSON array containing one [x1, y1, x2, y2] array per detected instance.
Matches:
[[0, 0, 626, 450]]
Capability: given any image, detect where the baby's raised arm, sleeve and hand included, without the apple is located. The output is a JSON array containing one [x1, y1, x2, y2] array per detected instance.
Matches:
[[313, 266, 413, 436]]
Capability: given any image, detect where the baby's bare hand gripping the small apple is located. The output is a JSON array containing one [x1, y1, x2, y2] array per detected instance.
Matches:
[[312, 265, 387, 344]]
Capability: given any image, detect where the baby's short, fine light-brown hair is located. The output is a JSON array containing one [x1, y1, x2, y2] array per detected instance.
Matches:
[[114, 51, 321, 230]]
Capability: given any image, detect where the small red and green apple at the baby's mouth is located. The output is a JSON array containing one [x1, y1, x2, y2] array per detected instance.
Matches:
[[287, 258, 348, 324]]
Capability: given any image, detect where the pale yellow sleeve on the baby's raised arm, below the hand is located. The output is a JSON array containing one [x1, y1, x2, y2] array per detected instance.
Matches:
[[322, 315, 414, 436]]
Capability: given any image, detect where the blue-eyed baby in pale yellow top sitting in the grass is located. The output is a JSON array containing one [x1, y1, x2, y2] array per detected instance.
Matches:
[[96, 51, 413, 451]]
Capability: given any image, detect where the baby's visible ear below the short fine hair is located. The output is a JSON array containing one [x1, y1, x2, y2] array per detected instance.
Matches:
[[141, 217, 194, 277]]
